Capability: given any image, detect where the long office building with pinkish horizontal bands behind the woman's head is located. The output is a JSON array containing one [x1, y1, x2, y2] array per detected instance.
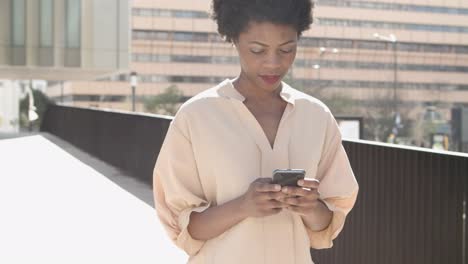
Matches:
[[45, 0, 468, 143]]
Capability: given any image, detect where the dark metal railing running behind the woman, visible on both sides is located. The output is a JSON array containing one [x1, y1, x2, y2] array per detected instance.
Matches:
[[41, 105, 468, 264]]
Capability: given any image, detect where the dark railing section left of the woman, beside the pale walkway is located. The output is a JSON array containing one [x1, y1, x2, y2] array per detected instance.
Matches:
[[41, 105, 172, 184]]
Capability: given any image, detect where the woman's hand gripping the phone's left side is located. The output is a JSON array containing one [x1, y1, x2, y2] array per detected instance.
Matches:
[[241, 178, 286, 217]]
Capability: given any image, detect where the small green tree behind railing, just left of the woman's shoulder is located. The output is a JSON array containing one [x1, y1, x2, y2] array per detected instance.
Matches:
[[143, 85, 184, 116]]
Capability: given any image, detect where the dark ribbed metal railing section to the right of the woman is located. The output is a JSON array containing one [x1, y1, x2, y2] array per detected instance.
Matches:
[[312, 141, 468, 264]]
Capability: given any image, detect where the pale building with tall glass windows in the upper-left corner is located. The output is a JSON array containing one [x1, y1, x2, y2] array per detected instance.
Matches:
[[0, 0, 131, 77]]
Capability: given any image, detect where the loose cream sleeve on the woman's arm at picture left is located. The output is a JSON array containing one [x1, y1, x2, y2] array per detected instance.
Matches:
[[153, 116, 210, 256]]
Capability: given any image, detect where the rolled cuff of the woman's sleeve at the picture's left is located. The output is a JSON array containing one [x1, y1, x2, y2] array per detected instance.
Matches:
[[176, 203, 211, 256]]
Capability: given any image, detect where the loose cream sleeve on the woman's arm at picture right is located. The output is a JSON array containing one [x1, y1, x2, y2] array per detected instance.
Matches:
[[306, 113, 359, 249]]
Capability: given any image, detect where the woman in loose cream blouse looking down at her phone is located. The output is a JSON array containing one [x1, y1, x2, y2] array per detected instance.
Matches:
[[154, 0, 358, 264]]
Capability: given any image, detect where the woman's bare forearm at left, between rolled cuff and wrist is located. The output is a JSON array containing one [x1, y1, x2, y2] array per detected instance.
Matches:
[[188, 197, 247, 241]]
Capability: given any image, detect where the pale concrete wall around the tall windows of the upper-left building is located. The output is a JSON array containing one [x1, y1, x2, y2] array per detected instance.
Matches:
[[0, 0, 130, 80]]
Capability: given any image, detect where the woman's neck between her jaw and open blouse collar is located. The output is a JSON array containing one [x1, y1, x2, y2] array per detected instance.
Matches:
[[233, 72, 281, 101]]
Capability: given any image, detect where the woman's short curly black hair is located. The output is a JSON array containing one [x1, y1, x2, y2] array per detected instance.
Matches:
[[212, 0, 314, 42]]
